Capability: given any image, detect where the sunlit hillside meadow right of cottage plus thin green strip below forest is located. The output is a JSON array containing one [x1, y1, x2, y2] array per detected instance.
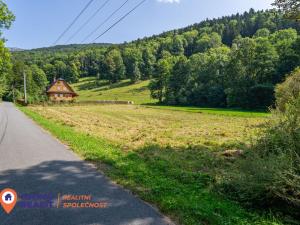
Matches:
[[72, 77, 269, 117]]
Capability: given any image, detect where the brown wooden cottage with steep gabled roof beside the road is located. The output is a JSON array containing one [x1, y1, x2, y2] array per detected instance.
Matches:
[[47, 79, 78, 102]]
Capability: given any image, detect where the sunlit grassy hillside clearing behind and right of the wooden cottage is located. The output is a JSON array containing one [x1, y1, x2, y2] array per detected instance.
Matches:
[[72, 77, 156, 104]]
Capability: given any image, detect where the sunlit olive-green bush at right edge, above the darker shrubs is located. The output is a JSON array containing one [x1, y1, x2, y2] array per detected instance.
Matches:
[[275, 67, 300, 111]]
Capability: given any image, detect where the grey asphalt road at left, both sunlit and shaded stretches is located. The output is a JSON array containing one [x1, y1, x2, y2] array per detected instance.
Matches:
[[0, 102, 171, 225]]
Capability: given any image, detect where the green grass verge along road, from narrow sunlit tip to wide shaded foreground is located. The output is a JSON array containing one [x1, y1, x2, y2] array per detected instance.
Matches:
[[20, 107, 281, 225]]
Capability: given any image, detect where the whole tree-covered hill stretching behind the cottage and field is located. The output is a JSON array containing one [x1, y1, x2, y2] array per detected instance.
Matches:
[[7, 9, 300, 108]]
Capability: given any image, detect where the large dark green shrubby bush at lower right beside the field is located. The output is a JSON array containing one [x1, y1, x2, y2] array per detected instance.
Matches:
[[221, 97, 300, 216]]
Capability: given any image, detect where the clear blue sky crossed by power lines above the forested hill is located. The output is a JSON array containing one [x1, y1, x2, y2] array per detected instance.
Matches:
[[4, 0, 273, 49]]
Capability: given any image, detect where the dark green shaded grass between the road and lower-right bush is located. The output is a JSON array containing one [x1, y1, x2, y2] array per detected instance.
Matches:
[[86, 144, 255, 224]]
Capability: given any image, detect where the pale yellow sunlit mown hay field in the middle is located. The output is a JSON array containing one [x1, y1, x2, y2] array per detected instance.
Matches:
[[24, 105, 267, 149]]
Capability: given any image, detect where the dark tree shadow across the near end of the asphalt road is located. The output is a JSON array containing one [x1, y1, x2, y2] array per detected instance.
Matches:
[[0, 161, 168, 225]]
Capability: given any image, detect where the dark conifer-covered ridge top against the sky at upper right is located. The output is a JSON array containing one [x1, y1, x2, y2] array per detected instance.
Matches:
[[139, 9, 300, 45]]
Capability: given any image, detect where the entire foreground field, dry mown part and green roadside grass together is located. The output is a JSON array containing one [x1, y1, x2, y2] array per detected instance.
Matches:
[[21, 105, 281, 225]]
